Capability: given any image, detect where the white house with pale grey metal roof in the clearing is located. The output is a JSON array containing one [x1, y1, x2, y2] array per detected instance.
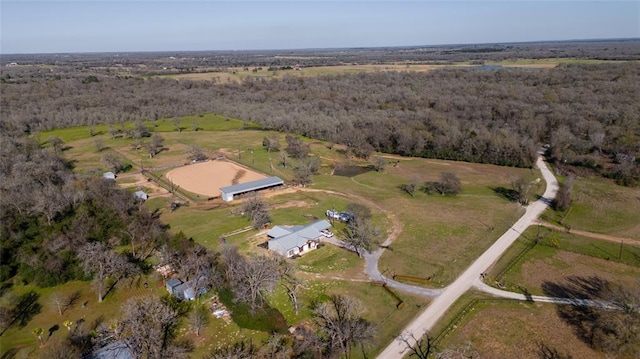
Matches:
[[267, 219, 331, 258]]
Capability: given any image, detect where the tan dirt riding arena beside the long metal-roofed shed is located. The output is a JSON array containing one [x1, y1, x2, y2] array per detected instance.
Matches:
[[165, 161, 267, 197]]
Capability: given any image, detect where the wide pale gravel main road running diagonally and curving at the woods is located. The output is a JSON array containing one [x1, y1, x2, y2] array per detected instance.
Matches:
[[378, 157, 558, 359]]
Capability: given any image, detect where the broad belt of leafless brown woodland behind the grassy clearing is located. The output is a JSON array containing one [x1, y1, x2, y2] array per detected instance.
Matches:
[[0, 63, 640, 185]]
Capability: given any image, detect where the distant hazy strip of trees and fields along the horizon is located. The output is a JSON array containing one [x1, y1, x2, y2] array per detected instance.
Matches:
[[0, 39, 640, 75]]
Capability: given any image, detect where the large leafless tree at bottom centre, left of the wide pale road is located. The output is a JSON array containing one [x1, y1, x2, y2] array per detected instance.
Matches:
[[313, 295, 377, 358]]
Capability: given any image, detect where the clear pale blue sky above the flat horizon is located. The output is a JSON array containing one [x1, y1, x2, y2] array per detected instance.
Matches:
[[0, 0, 640, 54]]
